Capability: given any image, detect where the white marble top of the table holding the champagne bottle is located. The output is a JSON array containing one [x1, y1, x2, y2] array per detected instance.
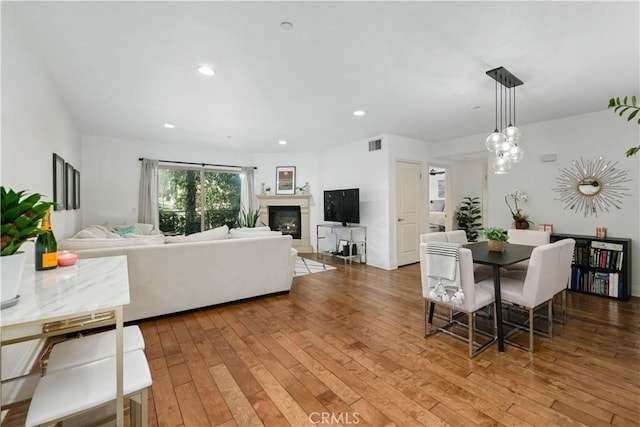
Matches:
[[0, 255, 129, 328]]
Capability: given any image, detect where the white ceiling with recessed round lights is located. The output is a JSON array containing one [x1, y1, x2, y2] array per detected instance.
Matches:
[[2, 1, 640, 152]]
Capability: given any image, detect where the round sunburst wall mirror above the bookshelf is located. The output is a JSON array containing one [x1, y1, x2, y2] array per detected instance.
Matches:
[[553, 156, 631, 217]]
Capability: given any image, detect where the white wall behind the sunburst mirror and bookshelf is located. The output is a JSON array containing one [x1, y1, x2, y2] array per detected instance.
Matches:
[[432, 111, 640, 296]]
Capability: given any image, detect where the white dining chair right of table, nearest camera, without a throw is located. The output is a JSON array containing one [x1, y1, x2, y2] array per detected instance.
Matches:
[[500, 243, 561, 352]]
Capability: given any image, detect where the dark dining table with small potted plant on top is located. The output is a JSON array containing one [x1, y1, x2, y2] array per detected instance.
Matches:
[[462, 241, 535, 352]]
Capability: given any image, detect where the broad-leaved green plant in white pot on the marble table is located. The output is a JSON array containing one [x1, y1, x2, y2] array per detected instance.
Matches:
[[0, 187, 54, 302]]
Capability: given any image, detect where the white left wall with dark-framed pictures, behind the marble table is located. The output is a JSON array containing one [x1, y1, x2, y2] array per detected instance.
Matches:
[[0, 3, 83, 398]]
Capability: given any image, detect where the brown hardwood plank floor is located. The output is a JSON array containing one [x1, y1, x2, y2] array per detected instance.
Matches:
[[5, 255, 640, 427]]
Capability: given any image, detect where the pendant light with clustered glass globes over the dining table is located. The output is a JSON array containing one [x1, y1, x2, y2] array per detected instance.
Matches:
[[485, 67, 524, 174]]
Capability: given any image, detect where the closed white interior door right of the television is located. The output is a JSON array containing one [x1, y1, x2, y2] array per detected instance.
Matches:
[[396, 160, 422, 267]]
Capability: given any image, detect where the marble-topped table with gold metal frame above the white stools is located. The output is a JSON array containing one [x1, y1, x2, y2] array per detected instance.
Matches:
[[0, 256, 129, 427]]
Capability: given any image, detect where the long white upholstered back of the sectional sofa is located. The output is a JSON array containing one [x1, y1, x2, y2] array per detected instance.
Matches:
[[77, 232, 297, 321]]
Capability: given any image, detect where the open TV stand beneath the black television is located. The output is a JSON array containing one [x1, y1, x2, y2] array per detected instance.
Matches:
[[316, 223, 367, 264]]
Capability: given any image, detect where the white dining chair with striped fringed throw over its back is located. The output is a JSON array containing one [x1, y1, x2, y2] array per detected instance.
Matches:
[[420, 242, 496, 358]]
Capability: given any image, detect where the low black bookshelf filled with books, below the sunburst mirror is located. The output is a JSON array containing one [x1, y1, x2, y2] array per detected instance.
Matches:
[[551, 234, 631, 301]]
